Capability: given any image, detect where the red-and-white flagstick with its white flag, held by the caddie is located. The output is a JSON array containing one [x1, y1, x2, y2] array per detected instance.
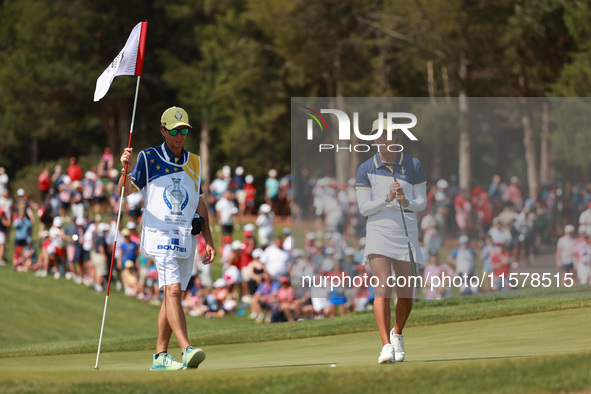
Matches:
[[94, 22, 148, 369]]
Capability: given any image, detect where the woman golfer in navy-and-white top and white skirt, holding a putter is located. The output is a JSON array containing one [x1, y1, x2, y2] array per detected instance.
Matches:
[[356, 119, 427, 364]]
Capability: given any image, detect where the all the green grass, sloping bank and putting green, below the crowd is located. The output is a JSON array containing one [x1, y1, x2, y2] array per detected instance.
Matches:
[[0, 269, 591, 393]]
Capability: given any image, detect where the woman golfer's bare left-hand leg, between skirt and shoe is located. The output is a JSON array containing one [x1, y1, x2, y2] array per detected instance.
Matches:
[[369, 255, 392, 345]]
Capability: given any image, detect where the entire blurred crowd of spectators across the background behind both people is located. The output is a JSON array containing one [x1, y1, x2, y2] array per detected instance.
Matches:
[[0, 157, 591, 322]]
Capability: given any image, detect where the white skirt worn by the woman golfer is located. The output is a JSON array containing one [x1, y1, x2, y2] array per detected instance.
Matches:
[[363, 208, 425, 264]]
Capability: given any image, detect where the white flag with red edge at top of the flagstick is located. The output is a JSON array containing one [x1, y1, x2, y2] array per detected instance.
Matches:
[[94, 22, 148, 101]]
